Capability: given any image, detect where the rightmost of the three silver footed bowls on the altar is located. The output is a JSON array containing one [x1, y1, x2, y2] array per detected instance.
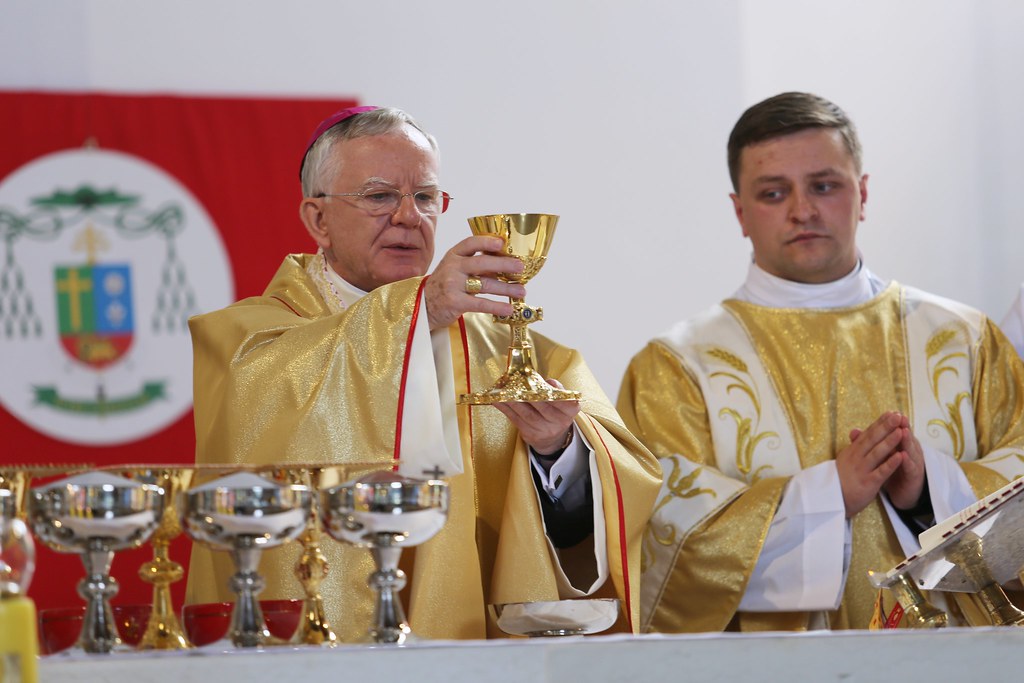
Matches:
[[321, 471, 449, 645]]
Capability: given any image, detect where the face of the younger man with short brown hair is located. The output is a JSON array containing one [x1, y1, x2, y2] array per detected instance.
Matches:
[[730, 128, 867, 284]]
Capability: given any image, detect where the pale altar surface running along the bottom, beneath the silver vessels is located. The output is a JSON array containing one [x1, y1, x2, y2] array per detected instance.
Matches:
[[39, 627, 1024, 683]]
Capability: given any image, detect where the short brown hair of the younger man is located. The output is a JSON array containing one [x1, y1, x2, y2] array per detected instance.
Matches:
[[727, 92, 861, 191]]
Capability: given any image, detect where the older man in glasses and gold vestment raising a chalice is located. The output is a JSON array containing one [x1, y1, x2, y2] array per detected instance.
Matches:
[[186, 106, 659, 641]]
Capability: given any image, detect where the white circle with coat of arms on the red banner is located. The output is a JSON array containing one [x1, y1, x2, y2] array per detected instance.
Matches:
[[0, 148, 234, 445]]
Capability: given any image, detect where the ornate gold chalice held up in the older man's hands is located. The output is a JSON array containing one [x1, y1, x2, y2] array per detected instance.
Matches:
[[459, 213, 580, 405]]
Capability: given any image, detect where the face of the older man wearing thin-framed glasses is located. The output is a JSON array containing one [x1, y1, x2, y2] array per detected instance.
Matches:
[[301, 126, 437, 292]]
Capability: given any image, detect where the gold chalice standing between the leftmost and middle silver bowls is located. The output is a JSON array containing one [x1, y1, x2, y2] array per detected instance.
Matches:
[[117, 465, 195, 650]]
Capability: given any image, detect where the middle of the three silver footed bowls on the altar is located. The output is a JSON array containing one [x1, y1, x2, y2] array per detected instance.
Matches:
[[181, 472, 312, 647]]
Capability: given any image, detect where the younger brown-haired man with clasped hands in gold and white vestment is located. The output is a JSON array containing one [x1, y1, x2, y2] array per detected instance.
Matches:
[[618, 92, 1024, 632]]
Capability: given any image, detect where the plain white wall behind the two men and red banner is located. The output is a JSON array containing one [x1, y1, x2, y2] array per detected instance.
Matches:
[[0, 0, 1024, 397]]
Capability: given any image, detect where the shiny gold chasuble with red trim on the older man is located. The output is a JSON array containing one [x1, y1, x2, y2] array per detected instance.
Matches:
[[186, 255, 660, 642]]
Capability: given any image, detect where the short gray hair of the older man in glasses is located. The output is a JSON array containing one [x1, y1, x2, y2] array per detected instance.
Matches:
[[301, 106, 438, 197]]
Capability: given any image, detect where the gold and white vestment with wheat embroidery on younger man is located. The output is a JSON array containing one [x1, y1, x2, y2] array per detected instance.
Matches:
[[618, 283, 1024, 632]]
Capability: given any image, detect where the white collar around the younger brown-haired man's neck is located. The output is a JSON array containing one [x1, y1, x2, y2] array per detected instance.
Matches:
[[733, 260, 886, 308]]
